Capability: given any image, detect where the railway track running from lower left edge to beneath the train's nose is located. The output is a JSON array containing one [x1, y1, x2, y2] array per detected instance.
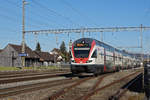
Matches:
[[0, 79, 77, 98]]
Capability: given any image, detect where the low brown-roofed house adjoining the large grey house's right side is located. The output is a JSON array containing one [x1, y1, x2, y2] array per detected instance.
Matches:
[[34, 51, 54, 66]]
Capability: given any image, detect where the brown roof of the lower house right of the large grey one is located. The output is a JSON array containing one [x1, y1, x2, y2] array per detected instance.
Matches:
[[34, 51, 54, 61]]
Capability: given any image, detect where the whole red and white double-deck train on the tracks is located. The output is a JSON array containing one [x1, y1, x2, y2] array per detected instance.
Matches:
[[71, 38, 140, 75]]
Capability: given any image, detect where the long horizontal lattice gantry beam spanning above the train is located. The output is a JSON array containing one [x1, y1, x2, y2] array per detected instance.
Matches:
[[25, 26, 150, 34]]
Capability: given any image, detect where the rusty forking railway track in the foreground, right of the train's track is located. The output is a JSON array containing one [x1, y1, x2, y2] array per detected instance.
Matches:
[[42, 71, 141, 100]]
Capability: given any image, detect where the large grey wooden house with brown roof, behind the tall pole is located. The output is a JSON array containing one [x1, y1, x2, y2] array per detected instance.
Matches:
[[0, 44, 40, 67]]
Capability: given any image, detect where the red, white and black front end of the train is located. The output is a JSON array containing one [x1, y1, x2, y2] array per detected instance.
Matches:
[[71, 38, 95, 74]]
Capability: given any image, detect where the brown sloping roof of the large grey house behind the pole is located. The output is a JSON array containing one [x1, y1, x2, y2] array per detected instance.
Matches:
[[8, 44, 39, 58]]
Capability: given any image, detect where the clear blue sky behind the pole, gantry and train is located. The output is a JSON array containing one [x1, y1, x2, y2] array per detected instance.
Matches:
[[0, 0, 150, 52]]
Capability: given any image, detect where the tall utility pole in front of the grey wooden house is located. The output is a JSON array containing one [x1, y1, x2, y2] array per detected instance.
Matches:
[[21, 0, 26, 68]]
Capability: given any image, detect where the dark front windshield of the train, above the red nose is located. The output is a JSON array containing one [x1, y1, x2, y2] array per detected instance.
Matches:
[[74, 50, 90, 58]]
